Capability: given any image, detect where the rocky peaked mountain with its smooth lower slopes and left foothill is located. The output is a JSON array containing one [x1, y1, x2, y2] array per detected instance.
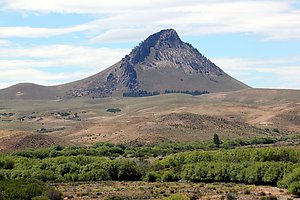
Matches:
[[0, 29, 249, 99]]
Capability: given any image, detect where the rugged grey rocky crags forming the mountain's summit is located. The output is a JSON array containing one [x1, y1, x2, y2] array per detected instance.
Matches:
[[121, 29, 224, 90]]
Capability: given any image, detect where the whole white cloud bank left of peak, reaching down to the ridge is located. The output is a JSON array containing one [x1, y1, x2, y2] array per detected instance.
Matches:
[[0, 45, 129, 87]]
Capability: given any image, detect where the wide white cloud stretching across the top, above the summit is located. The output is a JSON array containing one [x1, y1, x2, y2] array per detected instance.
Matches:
[[0, 0, 300, 42]]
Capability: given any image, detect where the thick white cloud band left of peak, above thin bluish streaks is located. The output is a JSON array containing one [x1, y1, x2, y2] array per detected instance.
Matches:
[[0, 45, 129, 70]]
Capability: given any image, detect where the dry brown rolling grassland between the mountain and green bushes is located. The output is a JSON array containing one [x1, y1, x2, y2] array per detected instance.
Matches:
[[0, 89, 300, 150]]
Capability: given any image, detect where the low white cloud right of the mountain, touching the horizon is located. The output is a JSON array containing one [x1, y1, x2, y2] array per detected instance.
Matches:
[[213, 56, 300, 89]]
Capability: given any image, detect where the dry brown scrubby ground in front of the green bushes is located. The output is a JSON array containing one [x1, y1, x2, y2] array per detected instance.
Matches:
[[55, 182, 294, 200]]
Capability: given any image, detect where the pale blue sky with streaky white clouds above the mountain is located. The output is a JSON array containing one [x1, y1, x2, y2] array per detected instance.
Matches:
[[0, 0, 300, 89]]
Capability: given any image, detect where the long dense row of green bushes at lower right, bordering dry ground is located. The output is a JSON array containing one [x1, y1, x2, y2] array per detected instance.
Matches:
[[181, 161, 292, 185]]
